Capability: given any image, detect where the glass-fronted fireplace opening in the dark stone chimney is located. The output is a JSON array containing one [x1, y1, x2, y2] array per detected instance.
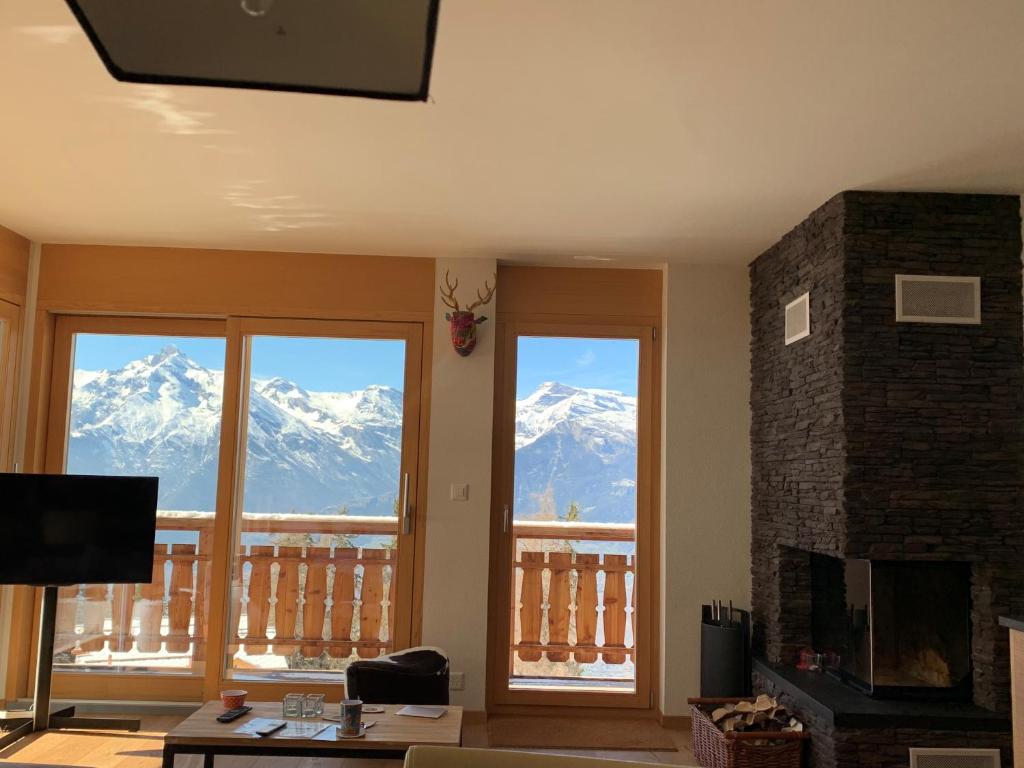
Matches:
[[811, 555, 972, 700]]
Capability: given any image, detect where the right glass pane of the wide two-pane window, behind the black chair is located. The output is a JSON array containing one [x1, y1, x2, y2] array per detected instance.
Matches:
[[228, 336, 406, 678]]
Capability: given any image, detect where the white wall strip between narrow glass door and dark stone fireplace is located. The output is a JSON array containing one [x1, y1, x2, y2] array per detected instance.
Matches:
[[659, 264, 751, 715]]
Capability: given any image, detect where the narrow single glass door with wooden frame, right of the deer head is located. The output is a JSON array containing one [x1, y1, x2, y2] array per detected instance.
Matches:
[[490, 326, 652, 707]]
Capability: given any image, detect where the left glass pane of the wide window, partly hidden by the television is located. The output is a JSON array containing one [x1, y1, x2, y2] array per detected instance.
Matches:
[[54, 334, 225, 674]]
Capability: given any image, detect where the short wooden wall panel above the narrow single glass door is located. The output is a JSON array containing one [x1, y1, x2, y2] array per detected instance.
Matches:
[[498, 266, 662, 326]]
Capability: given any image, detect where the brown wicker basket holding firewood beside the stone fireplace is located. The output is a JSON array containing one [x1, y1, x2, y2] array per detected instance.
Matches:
[[687, 697, 808, 768]]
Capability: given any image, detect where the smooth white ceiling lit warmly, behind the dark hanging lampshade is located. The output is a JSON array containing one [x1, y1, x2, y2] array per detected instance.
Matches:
[[0, 0, 1024, 264]]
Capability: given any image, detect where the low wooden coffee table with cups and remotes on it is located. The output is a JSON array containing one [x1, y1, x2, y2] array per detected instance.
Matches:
[[163, 701, 462, 768]]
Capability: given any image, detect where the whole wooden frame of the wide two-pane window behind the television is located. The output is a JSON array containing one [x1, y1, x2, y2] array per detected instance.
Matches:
[[9, 315, 430, 702]]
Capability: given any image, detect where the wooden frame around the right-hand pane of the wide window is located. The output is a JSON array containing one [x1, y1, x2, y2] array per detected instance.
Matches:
[[214, 317, 426, 700]]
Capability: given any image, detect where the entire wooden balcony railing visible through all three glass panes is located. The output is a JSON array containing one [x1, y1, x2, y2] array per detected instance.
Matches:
[[55, 513, 636, 668]]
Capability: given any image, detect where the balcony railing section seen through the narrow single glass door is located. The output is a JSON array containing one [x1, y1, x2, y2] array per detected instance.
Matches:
[[510, 521, 636, 676]]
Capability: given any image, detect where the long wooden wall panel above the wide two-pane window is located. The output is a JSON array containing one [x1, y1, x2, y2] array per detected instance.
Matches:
[[39, 245, 436, 321]]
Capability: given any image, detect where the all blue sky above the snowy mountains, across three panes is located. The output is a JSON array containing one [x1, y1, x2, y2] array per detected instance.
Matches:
[[75, 334, 640, 398]]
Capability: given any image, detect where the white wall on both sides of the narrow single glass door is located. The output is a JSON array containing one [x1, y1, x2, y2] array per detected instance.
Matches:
[[423, 259, 751, 715]]
